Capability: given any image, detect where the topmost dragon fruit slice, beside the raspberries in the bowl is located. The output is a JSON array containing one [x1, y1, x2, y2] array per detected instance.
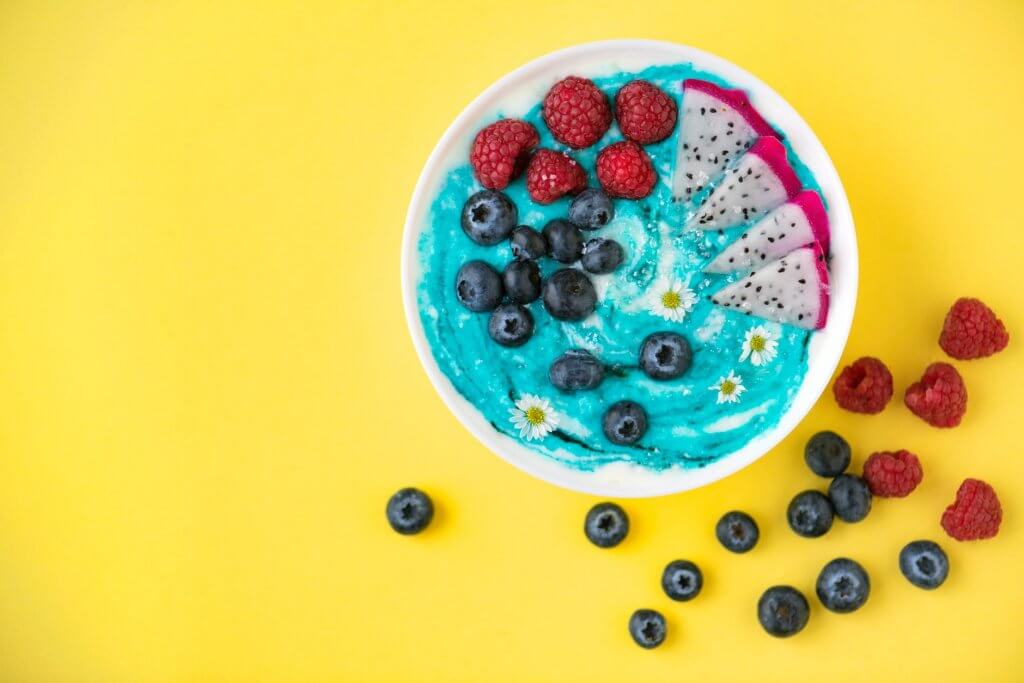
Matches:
[[672, 78, 777, 202]]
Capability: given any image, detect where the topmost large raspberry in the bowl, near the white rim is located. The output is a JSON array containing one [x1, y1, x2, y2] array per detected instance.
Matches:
[[544, 76, 611, 150]]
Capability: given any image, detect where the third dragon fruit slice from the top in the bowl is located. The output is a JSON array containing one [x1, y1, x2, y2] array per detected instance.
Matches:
[[705, 189, 828, 272]]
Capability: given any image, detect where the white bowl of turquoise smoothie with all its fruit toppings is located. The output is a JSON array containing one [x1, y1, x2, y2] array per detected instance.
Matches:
[[401, 41, 857, 497]]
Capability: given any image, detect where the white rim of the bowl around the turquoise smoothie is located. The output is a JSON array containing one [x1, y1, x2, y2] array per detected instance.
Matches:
[[401, 40, 857, 498]]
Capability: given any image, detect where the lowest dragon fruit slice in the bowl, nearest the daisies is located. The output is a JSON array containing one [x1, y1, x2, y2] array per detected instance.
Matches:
[[711, 243, 828, 330]]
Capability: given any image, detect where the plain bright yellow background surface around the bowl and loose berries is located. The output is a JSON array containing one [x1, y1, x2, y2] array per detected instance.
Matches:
[[0, 0, 1024, 683]]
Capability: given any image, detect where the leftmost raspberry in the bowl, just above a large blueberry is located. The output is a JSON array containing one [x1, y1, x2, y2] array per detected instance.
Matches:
[[469, 119, 541, 189]]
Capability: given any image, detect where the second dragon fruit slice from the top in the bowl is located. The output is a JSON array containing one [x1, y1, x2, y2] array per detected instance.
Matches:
[[686, 137, 801, 230]]
